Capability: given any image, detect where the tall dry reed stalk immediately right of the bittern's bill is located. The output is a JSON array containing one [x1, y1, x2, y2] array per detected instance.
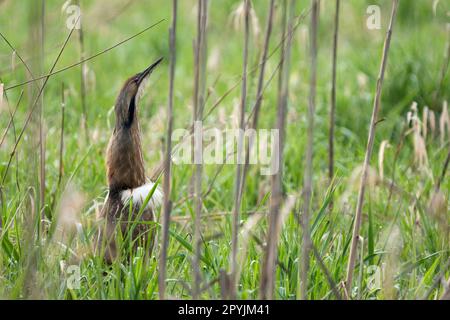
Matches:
[[158, 0, 178, 300]]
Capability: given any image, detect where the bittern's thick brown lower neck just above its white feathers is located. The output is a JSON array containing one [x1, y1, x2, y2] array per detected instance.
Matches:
[[106, 119, 146, 191]]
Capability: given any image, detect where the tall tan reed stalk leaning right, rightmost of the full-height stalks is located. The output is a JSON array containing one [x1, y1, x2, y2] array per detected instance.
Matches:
[[345, 0, 399, 297]]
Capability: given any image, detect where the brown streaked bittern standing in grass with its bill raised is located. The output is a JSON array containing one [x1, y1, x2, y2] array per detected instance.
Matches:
[[97, 58, 162, 262]]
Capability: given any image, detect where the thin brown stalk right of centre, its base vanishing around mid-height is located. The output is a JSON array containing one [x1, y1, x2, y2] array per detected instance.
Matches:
[[328, 0, 341, 185]]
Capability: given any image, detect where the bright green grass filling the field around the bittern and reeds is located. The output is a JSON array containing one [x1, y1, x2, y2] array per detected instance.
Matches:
[[0, 0, 450, 299]]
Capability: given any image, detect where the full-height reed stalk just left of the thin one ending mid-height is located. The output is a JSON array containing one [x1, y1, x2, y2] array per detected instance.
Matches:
[[299, 0, 320, 300]]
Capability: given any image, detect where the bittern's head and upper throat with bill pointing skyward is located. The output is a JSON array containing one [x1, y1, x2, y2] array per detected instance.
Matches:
[[115, 58, 162, 128]]
